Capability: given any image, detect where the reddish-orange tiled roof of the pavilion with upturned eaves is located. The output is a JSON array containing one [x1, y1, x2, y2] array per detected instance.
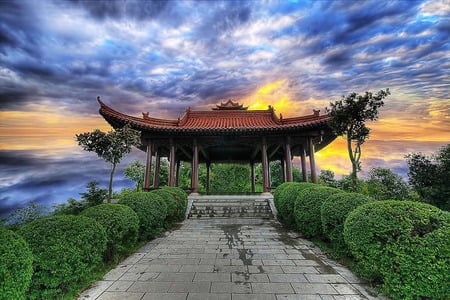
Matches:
[[97, 98, 329, 132]]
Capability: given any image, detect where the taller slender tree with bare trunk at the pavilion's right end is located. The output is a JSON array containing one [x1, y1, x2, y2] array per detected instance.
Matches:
[[326, 89, 390, 190]]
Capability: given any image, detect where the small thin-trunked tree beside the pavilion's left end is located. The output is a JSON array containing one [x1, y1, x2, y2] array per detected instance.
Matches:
[[76, 124, 140, 203]]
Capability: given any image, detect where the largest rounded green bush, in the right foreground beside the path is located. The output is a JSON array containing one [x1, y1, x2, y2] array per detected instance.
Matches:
[[344, 200, 450, 299]]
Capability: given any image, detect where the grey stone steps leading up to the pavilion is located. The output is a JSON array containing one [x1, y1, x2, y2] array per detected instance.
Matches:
[[187, 194, 274, 219]]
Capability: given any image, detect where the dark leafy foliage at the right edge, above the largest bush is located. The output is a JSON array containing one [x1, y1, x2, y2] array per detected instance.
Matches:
[[406, 144, 450, 211]]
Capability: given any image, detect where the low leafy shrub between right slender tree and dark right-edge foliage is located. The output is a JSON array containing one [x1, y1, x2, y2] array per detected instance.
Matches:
[[367, 168, 411, 200]]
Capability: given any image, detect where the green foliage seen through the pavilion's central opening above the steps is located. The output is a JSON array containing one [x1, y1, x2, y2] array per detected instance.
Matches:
[[210, 164, 250, 195]]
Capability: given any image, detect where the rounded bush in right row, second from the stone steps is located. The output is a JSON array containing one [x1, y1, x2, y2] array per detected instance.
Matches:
[[292, 185, 342, 238]]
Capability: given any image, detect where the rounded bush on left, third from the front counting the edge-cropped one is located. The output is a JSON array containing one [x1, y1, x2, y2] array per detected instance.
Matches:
[[81, 204, 139, 261]]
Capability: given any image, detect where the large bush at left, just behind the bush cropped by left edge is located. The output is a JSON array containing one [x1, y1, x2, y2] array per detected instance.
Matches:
[[19, 215, 106, 299]]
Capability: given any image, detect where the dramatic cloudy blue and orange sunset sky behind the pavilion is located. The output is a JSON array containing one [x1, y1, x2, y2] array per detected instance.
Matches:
[[0, 0, 450, 216]]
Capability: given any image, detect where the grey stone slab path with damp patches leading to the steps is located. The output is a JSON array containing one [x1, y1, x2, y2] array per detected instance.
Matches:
[[78, 219, 386, 300]]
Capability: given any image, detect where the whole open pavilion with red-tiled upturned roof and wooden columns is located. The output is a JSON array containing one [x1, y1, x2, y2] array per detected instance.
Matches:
[[97, 97, 336, 193]]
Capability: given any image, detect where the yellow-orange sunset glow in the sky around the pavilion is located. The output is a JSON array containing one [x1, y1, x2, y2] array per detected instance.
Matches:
[[0, 79, 450, 178]]
